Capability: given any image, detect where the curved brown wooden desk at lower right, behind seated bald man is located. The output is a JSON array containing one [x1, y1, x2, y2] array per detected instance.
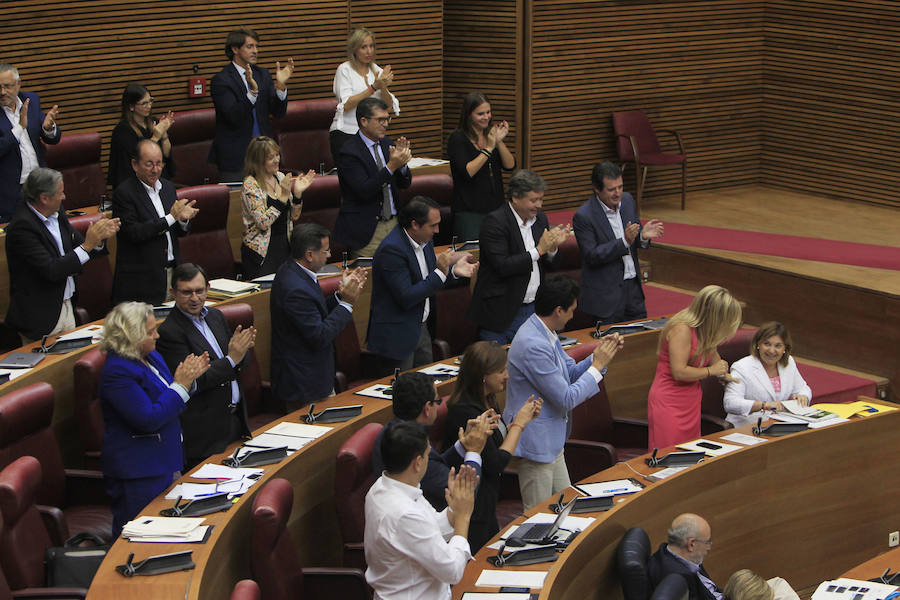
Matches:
[[453, 411, 900, 600]]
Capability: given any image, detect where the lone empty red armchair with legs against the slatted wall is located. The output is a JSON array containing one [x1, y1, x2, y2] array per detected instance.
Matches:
[[613, 109, 687, 211]]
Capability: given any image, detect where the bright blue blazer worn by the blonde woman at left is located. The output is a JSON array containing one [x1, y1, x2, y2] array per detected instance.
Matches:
[[99, 351, 184, 479]]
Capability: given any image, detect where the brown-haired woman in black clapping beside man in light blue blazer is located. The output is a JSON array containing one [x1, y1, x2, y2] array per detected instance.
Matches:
[[444, 342, 543, 553]]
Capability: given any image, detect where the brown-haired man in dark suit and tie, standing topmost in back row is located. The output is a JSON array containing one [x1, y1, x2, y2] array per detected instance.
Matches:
[[209, 28, 294, 182]]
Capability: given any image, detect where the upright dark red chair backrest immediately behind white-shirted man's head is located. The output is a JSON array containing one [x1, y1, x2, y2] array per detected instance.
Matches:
[[334, 423, 383, 544]]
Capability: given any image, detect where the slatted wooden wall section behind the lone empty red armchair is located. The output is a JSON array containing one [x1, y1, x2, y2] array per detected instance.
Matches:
[[525, 0, 763, 208]]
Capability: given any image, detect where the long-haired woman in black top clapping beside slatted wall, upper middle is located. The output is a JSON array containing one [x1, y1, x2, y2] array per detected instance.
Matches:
[[447, 92, 516, 241]]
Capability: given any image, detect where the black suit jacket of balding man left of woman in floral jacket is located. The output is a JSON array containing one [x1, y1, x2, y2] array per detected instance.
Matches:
[[113, 176, 185, 305]]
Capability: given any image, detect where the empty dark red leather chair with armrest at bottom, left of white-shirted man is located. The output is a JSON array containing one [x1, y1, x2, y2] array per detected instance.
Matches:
[[250, 478, 368, 600]]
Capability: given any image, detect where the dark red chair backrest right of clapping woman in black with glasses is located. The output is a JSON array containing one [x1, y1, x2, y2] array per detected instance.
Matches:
[[168, 108, 219, 185]]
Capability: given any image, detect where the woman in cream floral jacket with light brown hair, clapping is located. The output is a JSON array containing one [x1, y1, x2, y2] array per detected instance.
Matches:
[[241, 136, 316, 281]]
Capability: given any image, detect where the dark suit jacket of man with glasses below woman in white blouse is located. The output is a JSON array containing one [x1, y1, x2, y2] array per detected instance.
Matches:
[[334, 134, 412, 248]]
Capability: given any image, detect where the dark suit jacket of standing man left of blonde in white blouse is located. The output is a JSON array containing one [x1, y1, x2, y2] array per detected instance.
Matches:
[[209, 63, 287, 171]]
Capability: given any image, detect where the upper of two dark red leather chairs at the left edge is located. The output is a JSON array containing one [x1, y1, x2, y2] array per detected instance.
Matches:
[[0, 382, 112, 544]]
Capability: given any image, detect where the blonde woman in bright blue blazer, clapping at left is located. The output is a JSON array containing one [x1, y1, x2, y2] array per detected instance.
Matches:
[[99, 302, 209, 537]]
